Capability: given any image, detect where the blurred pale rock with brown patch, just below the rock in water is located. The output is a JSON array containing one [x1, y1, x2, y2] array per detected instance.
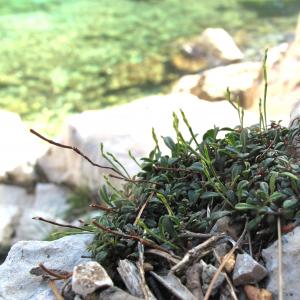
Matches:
[[174, 62, 261, 107]]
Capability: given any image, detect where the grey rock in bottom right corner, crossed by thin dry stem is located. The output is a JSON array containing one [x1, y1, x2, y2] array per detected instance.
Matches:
[[262, 227, 300, 300]]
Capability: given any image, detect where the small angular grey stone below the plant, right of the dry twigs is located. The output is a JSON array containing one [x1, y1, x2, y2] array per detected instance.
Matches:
[[232, 253, 268, 286]]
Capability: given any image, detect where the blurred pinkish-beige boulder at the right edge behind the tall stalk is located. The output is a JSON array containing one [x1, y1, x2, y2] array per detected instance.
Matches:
[[246, 17, 300, 114]]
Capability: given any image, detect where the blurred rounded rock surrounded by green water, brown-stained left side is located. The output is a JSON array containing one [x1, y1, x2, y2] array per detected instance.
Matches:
[[172, 28, 244, 73]]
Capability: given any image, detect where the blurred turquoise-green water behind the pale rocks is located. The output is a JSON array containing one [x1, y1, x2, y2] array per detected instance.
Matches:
[[0, 0, 300, 131]]
